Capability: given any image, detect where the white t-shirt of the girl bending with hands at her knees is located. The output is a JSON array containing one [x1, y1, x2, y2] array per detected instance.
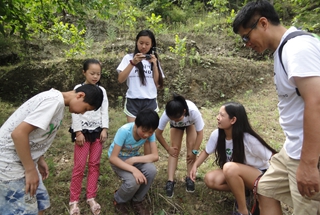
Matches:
[[158, 100, 204, 131]]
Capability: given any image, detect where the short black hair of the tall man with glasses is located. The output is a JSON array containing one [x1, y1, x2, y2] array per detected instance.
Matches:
[[232, 0, 280, 34]]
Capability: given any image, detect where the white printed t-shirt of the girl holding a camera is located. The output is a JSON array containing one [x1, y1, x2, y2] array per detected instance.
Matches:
[[117, 54, 164, 99]]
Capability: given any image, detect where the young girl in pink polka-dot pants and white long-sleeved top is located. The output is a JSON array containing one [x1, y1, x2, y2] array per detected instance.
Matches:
[[69, 59, 109, 215]]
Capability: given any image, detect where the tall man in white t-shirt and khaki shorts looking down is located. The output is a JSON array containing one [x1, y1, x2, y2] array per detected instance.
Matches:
[[233, 0, 320, 215]]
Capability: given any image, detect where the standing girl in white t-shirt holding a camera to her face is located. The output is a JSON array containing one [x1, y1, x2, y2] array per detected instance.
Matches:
[[117, 30, 164, 122]]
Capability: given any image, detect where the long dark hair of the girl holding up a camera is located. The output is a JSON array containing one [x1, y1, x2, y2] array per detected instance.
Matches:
[[133, 30, 163, 89]]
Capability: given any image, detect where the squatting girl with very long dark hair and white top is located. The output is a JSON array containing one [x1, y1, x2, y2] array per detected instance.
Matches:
[[190, 102, 276, 215]]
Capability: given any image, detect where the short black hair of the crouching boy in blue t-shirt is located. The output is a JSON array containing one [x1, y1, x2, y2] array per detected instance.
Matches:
[[134, 108, 159, 131]]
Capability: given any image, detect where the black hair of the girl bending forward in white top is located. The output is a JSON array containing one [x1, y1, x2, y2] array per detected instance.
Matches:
[[166, 93, 189, 119]]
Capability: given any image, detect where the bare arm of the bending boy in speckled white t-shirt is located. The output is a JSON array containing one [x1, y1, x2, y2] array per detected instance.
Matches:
[[11, 122, 39, 196]]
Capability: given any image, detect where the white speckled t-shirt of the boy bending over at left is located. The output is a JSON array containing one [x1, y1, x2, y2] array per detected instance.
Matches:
[[0, 89, 65, 181]]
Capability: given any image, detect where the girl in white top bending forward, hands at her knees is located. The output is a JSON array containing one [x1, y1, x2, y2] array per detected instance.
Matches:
[[156, 95, 204, 198]]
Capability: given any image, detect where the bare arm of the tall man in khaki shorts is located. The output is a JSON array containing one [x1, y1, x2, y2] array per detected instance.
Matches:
[[294, 77, 320, 197]]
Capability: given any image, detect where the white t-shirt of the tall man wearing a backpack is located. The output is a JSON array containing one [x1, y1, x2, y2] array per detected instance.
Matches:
[[274, 27, 320, 160]]
